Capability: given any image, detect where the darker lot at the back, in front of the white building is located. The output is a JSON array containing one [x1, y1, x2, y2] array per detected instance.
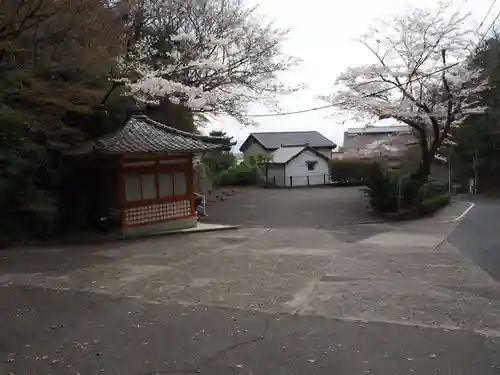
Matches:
[[204, 187, 376, 229]]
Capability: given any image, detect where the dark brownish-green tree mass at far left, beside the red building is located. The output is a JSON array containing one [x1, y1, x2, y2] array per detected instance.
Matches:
[[0, 0, 127, 241]]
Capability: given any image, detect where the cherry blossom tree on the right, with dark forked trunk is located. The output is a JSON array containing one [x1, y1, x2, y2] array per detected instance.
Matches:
[[327, 4, 487, 182]]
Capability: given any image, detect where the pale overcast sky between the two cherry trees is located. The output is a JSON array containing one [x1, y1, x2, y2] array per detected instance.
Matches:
[[202, 0, 500, 150]]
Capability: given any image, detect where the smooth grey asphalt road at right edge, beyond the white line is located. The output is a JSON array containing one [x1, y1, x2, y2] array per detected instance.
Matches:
[[448, 197, 500, 282]]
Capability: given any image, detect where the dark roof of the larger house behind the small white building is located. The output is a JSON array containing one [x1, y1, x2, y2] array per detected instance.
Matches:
[[240, 131, 337, 152]]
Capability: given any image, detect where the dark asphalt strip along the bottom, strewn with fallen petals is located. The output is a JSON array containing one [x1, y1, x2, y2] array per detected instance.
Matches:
[[0, 287, 500, 375]]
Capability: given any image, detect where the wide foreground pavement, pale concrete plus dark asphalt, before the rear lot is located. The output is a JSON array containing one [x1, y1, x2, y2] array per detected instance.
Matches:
[[0, 189, 500, 375]]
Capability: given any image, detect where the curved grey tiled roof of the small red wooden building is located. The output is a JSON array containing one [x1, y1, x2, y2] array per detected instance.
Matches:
[[94, 115, 219, 153]]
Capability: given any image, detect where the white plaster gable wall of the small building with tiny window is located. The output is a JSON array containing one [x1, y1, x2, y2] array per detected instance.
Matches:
[[285, 151, 329, 186]]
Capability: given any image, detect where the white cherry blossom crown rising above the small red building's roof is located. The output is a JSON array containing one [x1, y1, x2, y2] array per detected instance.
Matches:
[[108, 0, 298, 122]]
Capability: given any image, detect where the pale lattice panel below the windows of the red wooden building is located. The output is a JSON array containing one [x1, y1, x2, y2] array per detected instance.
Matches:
[[125, 200, 191, 225]]
